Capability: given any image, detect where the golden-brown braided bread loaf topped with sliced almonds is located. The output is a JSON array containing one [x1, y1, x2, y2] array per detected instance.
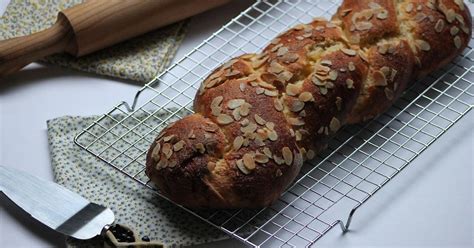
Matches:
[[146, 0, 471, 208]]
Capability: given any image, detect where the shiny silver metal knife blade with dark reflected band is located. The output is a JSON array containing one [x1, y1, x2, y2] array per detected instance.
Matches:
[[0, 166, 114, 239]]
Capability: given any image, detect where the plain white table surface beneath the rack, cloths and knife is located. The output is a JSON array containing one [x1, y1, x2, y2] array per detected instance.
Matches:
[[0, 0, 474, 247]]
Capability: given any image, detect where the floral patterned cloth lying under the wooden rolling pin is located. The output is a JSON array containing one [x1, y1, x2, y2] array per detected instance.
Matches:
[[0, 0, 187, 82]]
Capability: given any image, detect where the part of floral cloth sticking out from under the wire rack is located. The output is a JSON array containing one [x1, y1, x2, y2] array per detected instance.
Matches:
[[47, 116, 225, 247]]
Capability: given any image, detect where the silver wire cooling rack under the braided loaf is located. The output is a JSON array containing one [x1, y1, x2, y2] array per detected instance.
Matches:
[[75, 0, 474, 247]]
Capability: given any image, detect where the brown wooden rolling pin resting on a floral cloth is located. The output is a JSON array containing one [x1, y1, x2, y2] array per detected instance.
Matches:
[[0, 0, 230, 77]]
